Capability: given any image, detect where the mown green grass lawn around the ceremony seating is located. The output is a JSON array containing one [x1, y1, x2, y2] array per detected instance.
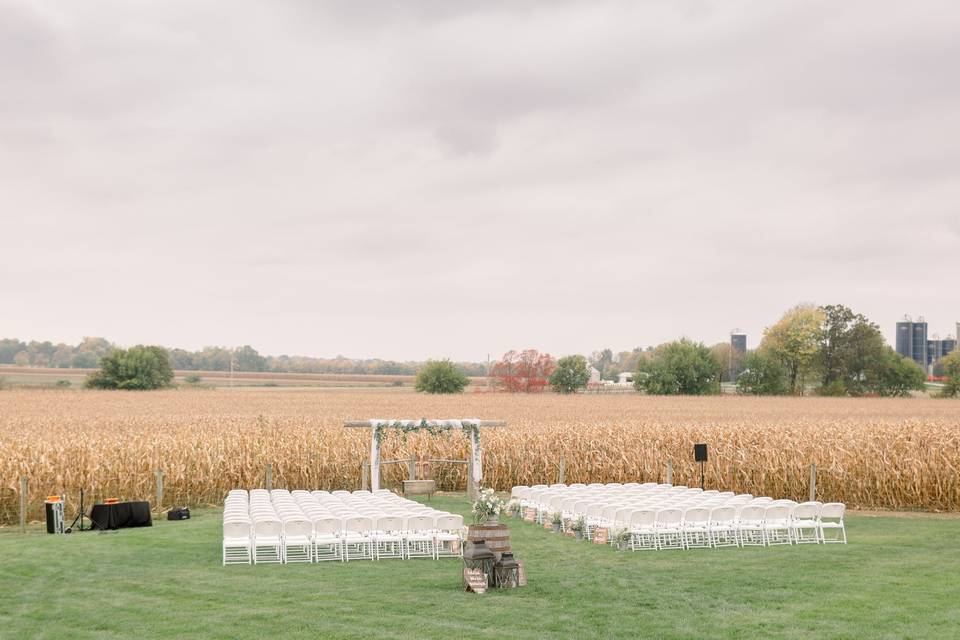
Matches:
[[0, 496, 960, 639]]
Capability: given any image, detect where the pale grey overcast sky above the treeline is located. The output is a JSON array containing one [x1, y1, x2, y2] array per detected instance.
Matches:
[[0, 0, 960, 360]]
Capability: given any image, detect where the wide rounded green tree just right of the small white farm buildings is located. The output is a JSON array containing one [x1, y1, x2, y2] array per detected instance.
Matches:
[[633, 338, 721, 395]]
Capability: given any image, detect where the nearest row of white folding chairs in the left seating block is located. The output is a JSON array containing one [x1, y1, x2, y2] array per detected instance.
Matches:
[[223, 513, 463, 565]]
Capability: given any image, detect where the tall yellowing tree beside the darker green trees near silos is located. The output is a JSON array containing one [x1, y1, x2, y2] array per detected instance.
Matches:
[[760, 305, 824, 395]]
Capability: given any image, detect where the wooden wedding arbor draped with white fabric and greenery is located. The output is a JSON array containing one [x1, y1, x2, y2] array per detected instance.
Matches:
[[343, 418, 507, 497]]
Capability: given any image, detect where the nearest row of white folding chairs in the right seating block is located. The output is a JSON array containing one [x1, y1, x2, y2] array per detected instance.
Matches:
[[627, 502, 847, 550]]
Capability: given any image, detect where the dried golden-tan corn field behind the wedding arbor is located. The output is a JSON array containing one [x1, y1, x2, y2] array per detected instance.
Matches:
[[0, 389, 960, 523]]
